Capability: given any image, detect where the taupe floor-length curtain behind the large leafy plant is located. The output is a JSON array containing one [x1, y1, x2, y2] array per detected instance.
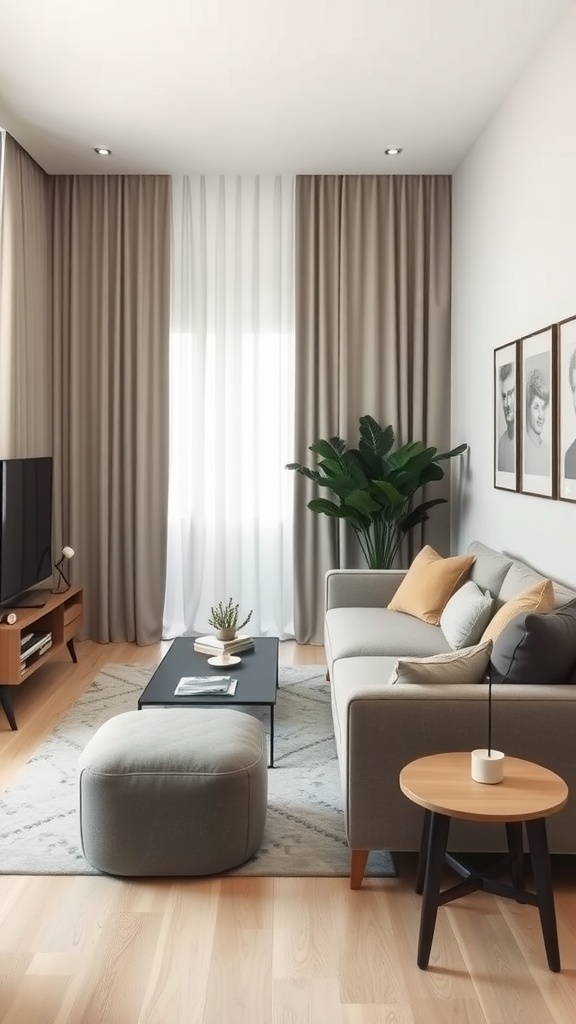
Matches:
[[294, 175, 450, 643]]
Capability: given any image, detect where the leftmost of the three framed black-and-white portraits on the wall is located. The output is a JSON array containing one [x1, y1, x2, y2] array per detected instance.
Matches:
[[493, 341, 520, 490]]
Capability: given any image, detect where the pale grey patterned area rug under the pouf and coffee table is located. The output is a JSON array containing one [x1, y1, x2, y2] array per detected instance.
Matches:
[[0, 665, 395, 877]]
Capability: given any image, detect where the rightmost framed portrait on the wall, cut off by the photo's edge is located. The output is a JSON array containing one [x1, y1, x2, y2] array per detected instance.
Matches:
[[558, 316, 576, 502]]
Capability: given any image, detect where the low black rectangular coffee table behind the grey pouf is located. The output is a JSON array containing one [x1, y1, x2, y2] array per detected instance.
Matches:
[[138, 637, 278, 768]]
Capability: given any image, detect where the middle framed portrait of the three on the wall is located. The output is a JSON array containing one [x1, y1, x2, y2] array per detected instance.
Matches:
[[518, 327, 557, 498]]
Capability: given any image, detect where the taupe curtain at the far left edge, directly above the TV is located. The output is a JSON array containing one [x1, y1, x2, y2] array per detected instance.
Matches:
[[0, 132, 52, 459]]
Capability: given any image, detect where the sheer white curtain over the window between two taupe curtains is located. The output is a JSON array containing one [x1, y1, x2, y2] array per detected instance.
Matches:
[[163, 176, 294, 637]]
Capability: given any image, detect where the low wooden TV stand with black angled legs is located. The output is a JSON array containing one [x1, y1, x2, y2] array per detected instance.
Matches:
[[0, 587, 84, 729]]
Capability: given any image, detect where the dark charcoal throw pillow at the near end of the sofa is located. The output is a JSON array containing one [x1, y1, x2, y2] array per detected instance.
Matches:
[[490, 604, 576, 685]]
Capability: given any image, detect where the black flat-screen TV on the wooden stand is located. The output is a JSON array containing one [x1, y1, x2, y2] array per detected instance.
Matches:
[[0, 457, 52, 607]]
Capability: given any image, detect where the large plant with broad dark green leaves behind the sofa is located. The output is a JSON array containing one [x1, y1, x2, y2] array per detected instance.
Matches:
[[286, 416, 467, 569]]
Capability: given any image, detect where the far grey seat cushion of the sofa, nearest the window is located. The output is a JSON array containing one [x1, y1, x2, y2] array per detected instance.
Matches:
[[326, 608, 451, 659]]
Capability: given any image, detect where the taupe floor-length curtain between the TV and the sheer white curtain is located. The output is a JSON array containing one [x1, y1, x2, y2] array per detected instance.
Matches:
[[52, 175, 170, 644]]
